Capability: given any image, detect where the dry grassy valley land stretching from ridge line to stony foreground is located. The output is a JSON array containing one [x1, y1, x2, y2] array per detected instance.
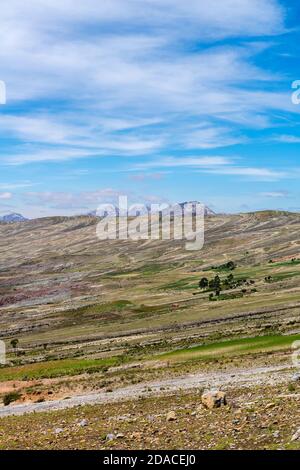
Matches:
[[0, 211, 300, 448]]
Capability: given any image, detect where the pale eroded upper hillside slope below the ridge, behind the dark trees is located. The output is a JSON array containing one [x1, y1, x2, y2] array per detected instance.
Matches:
[[0, 212, 300, 344]]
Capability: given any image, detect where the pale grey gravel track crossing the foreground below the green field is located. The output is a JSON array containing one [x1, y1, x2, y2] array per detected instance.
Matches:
[[0, 365, 292, 418]]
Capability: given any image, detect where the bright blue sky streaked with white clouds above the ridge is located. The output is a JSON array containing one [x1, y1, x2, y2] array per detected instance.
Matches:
[[0, 0, 300, 217]]
